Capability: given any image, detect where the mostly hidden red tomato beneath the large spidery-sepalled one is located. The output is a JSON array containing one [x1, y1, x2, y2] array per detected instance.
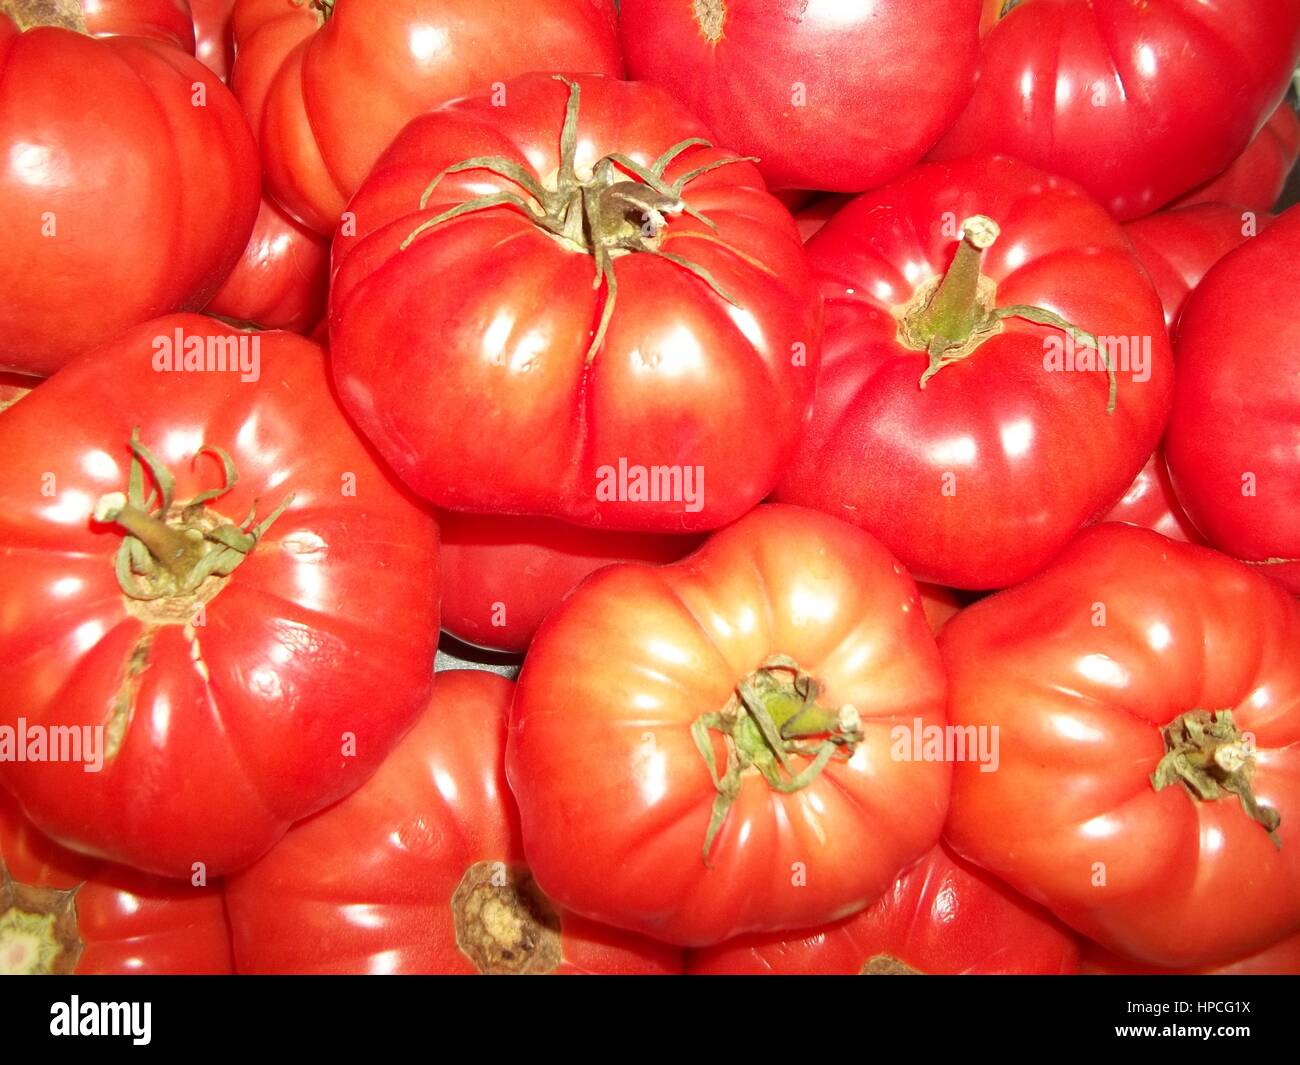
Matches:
[[438, 511, 699, 654]]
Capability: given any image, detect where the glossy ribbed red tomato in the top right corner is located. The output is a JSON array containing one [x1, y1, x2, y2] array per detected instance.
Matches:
[[931, 0, 1300, 218]]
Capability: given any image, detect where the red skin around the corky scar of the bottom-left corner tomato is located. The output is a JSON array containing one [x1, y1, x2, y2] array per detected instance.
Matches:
[[0, 789, 234, 977]]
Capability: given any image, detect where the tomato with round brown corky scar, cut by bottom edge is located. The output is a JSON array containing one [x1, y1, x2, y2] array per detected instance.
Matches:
[[226, 670, 683, 974]]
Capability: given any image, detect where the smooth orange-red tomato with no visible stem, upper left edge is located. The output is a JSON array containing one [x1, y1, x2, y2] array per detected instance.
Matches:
[[0, 0, 259, 375]]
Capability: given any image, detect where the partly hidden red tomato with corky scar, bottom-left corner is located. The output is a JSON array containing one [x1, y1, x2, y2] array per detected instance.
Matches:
[[0, 789, 231, 977]]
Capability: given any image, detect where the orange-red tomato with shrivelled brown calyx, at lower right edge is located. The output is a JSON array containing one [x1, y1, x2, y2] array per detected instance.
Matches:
[[939, 524, 1300, 967]]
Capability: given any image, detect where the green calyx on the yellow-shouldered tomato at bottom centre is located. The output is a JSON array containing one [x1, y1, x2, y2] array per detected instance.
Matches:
[[690, 655, 862, 866]]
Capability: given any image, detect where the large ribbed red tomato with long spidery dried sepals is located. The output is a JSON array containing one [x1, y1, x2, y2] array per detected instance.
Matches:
[[330, 74, 822, 533]]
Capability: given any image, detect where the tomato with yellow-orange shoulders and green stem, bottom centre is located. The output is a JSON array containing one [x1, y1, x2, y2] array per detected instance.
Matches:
[[506, 506, 950, 947]]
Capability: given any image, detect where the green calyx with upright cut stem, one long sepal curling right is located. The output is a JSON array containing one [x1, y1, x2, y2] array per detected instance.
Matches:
[[893, 215, 1118, 414]]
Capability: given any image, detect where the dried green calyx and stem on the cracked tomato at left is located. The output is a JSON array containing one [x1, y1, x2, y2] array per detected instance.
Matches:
[[94, 429, 294, 611]]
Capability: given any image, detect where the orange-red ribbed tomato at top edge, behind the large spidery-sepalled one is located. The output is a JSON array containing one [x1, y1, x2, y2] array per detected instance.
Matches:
[[233, 0, 623, 233]]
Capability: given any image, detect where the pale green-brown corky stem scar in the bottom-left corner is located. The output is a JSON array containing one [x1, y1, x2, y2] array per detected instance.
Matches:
[[0, 860, 86, 977]]
